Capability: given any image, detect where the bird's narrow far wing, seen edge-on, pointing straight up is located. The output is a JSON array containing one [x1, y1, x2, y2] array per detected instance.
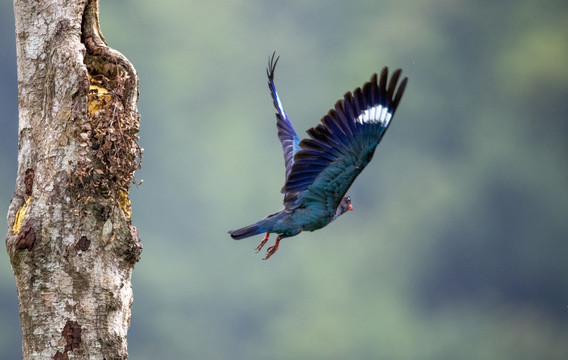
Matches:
[[266, 52, 300, 179]]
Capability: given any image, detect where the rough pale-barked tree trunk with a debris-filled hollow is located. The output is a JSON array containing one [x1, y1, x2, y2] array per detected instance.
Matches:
[[6, 0, 142, 359]]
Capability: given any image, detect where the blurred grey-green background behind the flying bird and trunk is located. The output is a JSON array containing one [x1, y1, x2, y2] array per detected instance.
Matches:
[[0, 0, 568, 360]]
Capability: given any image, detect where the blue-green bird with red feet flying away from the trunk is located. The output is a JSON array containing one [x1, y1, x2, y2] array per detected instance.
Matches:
[[228, 52, 408, 260]]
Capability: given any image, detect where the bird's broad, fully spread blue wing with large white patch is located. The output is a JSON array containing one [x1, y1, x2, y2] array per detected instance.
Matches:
[[282, 67, 407, 212]]
